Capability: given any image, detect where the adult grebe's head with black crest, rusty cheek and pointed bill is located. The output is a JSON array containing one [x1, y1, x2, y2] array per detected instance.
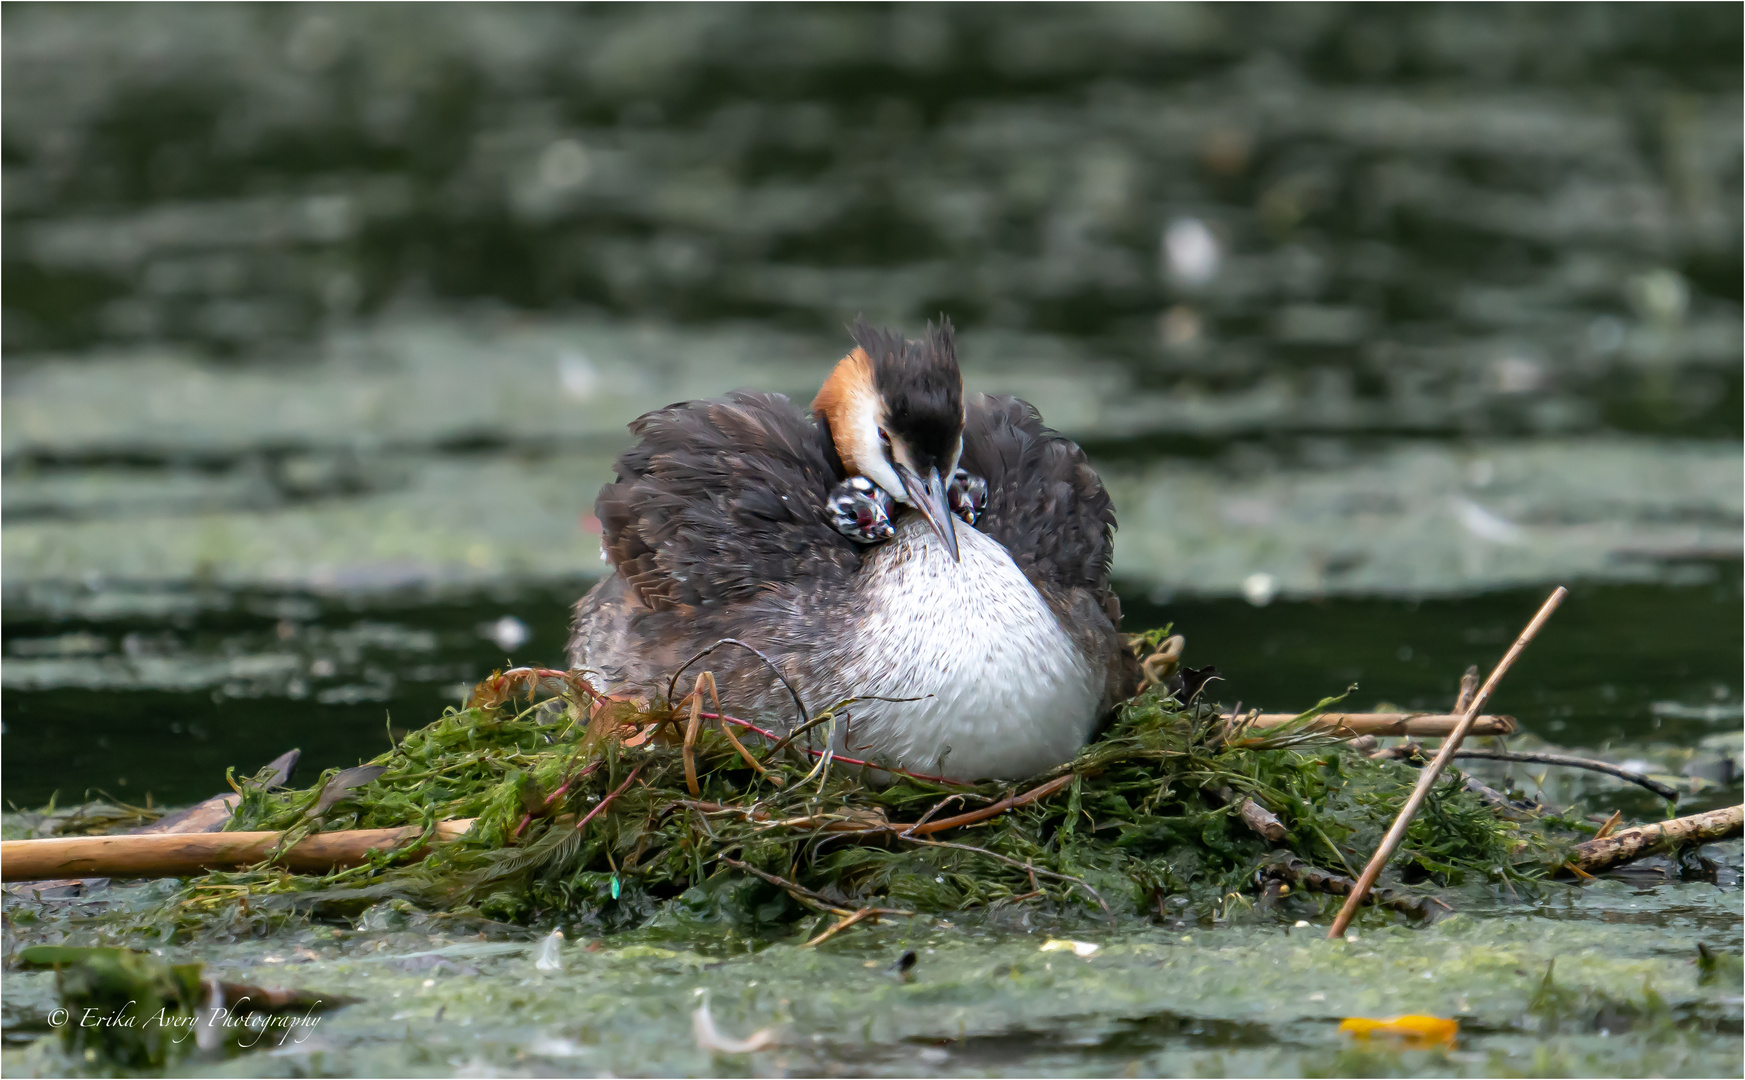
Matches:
[[811, 319, 963, 558]]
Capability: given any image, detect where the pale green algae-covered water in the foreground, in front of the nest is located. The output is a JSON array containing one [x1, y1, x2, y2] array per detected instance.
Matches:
[[5, 850, 1742, 1077]]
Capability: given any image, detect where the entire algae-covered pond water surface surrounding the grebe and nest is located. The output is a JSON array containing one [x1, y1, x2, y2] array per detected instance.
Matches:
[[0, 3, 1745, 1075]]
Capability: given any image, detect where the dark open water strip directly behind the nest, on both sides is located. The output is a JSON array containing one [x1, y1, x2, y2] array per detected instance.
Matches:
[[5, 565, 1742, 806]]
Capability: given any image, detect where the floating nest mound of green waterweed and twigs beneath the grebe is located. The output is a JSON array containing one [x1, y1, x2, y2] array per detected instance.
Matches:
[[173, 632, 1577, 933]]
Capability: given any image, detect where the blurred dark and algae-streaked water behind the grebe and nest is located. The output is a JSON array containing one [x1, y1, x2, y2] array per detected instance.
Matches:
[[0, 3, 1742, 796]]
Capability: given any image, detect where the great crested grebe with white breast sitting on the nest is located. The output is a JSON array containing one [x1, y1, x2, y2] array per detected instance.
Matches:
[[569, 321, 1131, 780]]
